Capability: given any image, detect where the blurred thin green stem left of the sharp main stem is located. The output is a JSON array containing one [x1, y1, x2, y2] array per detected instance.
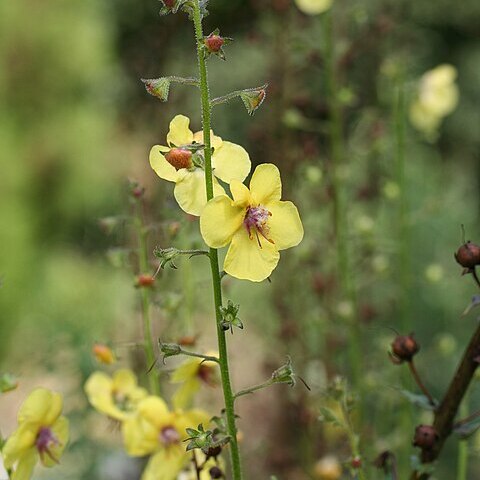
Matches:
[[135, 199, 160, 395]]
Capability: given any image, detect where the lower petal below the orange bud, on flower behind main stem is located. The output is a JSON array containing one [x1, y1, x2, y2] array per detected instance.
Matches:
[[173, 169, 225, 217]]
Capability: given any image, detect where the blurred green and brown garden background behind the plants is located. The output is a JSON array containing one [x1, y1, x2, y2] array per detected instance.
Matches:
[[0, 0, 480, 480]]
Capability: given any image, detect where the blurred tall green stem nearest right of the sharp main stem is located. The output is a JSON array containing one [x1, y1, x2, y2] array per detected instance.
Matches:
[[322, 11, 362, 389]]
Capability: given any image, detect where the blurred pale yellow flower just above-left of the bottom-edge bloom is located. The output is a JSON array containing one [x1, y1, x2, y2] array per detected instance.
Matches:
[[85, 369, 147, 421]]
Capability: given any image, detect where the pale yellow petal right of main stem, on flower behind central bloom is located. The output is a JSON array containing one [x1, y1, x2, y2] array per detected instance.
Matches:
[[212, 142, 252, 183]]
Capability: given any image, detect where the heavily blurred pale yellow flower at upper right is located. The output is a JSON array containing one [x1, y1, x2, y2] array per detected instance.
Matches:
[[410, 64, 459, 140]]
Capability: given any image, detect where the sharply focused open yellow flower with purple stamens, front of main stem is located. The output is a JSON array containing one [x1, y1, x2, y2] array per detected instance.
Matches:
[[200, 163, 303, 282]]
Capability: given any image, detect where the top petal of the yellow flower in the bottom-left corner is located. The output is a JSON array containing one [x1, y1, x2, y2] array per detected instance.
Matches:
[[18, 388, 63, 426]]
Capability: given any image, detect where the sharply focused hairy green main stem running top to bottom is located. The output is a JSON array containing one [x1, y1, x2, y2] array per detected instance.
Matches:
[[193, 0, 242, 480]]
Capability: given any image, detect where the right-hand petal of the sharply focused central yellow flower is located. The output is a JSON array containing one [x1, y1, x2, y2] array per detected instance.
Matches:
[[266, 202, 303, 250]]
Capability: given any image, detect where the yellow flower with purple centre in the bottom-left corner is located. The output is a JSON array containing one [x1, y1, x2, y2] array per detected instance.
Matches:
[[2, 388, 68, 480]]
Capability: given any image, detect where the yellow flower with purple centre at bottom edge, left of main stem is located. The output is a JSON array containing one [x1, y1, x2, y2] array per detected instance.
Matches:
[[122, 396, 209, 480]]
